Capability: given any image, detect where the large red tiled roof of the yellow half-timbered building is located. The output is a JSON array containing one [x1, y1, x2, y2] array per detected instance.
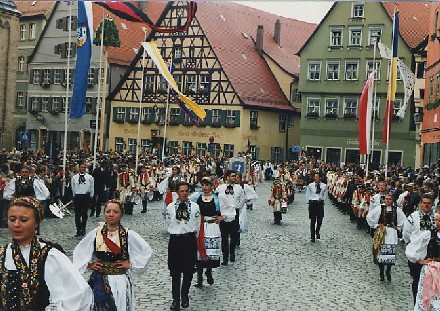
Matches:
[[196, 2, 316, 110]]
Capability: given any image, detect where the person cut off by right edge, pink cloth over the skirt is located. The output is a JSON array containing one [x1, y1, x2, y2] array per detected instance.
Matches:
[[405, 213, 440, 311]]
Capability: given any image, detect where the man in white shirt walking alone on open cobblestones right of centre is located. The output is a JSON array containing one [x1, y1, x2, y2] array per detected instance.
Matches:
[[306, 173, 327, 243]]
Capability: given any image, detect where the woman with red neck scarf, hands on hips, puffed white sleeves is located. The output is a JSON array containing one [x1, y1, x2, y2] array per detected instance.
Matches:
[[73, 200, 153, 311]]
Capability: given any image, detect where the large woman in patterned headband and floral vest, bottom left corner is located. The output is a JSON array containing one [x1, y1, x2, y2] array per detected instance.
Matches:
[[0, 197, 93, 311]]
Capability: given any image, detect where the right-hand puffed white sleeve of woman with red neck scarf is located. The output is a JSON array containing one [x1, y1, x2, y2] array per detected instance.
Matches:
[[128, 230, 153, 276]]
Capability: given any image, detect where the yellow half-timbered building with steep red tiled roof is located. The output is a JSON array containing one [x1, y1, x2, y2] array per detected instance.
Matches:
[[109, 2, 316, 160]]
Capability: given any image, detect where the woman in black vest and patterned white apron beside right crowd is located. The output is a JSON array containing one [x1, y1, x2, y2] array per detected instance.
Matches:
[[367, 193, 405, 281]]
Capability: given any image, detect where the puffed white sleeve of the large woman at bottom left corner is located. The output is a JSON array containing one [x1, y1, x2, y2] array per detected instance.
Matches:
[[44, 248, 93, 311]]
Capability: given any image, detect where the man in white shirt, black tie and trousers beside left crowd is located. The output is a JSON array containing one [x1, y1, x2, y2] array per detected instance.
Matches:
[[70, 163, 95, 237]]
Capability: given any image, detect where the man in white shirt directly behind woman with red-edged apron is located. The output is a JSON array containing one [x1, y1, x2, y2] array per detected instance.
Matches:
[[216, 170, 244, 266]]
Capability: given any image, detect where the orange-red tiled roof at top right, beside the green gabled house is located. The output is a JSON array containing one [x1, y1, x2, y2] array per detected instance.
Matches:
[[382, 1, 430, 48]]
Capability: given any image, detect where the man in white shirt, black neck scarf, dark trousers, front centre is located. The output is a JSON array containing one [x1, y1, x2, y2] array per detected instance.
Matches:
[[166, 182, 200, 310]]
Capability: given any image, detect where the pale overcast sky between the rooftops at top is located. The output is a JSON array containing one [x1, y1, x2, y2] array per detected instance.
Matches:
[[236, 1, 333, 23]]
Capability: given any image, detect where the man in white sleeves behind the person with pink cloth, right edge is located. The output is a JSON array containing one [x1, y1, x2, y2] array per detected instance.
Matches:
[[403, 194, 436, 303]]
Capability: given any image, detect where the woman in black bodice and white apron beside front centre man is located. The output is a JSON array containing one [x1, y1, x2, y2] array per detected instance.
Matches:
[[190, 177, 224, 287]]
